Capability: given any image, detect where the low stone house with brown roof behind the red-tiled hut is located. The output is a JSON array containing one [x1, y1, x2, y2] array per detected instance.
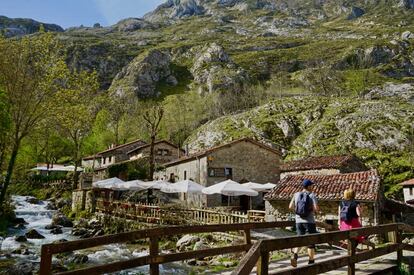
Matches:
[[280, 155, 368, 178]]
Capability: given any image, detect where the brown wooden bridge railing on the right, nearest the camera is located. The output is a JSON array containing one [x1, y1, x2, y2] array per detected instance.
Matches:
[[232, 223, 414, 275]]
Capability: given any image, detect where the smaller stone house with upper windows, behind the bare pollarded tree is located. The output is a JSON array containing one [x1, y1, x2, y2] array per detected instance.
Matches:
[[127, 140, 185, 164]]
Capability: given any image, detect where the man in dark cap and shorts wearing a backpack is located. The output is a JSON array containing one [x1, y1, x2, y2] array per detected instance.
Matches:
[[289, 179, 319, 267]]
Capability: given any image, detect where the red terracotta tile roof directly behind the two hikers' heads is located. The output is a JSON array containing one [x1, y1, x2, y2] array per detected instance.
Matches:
[[265, 170, 380, 201]]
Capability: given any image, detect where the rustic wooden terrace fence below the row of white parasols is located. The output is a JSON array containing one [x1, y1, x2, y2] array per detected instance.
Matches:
[[96, 199, 265, 225]]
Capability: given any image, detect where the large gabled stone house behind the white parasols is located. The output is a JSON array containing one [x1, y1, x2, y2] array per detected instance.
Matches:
[[154, 138, 281, 209]]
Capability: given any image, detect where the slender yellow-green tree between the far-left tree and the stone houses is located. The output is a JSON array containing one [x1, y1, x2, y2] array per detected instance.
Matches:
[[53, 69, 99, 188]]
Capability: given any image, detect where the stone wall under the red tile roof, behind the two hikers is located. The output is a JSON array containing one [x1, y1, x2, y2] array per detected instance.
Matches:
[[265, 200, 378, 226]]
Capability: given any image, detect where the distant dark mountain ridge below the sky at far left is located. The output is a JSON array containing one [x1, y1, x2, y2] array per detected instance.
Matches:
[[0, 16, 63, 37]]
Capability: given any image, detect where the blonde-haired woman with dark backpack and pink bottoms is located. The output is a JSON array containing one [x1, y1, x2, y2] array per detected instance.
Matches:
[[338, 188, 375, 247]]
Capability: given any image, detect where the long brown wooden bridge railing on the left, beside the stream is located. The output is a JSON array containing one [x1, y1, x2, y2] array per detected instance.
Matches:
[[40, 221, 331, 275]]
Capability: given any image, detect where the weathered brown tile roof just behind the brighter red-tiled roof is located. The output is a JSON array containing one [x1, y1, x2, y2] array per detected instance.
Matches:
[[280, 155, 355, 172]]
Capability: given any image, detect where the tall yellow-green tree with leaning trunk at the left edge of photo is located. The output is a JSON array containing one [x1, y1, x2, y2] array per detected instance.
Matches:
[[0, 33, 66, 204]]
